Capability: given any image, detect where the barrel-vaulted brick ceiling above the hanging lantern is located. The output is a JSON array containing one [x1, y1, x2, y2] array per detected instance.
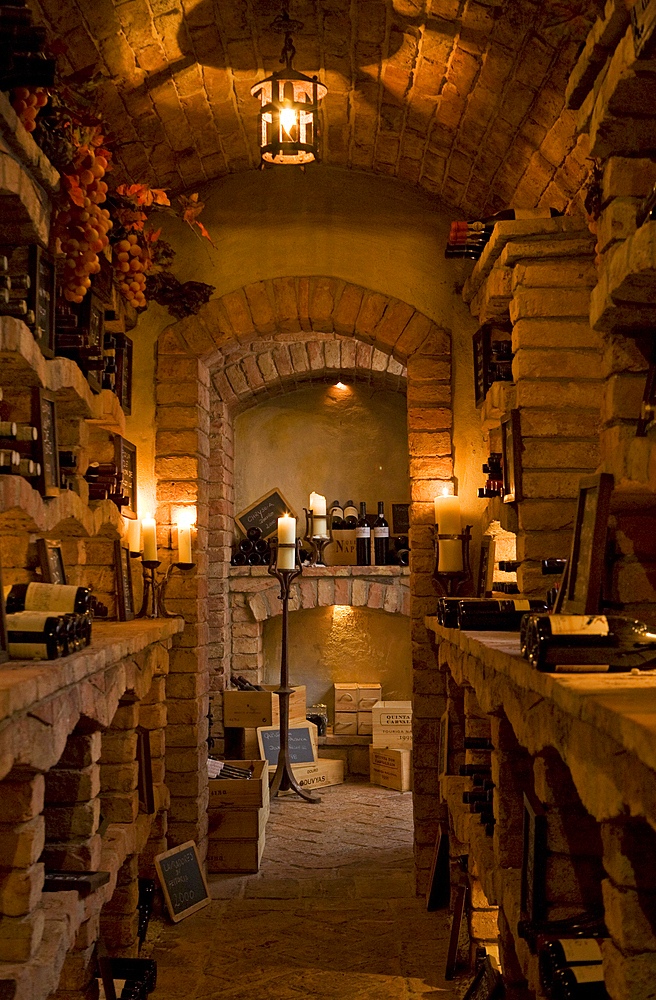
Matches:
[[29, 0, 599, 216]]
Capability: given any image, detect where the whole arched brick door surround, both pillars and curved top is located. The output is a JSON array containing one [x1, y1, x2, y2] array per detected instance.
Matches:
[[156, 277, 453, 892]]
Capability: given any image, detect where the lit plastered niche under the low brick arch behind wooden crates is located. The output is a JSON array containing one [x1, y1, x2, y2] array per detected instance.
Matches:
[[262, 604, 412, 715]]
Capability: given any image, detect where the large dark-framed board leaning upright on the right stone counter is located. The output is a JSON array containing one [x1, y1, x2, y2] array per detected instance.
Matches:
[[558, 472, 613, 615]]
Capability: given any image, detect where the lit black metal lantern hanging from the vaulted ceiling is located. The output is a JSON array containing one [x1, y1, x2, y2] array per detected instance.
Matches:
[[251, 11, 328, 166]]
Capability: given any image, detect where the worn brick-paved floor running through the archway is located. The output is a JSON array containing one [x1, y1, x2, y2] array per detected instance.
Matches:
[[147, 782, 466, 1000]]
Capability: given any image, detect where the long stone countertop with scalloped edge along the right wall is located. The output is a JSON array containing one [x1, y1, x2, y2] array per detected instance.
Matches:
[[425, 617, 656, 827]]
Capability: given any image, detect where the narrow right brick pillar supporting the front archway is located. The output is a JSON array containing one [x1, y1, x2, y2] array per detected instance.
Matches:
[[408, 328, 453, 892]]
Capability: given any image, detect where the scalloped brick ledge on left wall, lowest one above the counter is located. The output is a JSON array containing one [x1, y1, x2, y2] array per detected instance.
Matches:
[[0, 476, 123, 538]]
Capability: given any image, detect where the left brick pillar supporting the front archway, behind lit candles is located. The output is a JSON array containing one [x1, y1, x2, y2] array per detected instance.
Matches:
[[155, 331, 210, 856]]
